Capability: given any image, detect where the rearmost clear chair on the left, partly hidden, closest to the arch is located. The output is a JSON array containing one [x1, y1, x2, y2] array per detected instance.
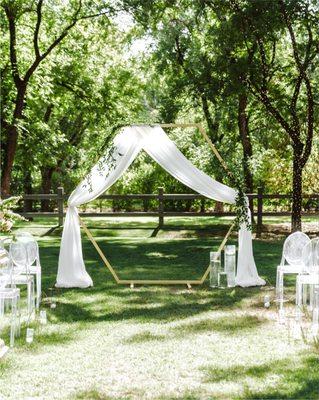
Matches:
[[15, 231, 42, 310]]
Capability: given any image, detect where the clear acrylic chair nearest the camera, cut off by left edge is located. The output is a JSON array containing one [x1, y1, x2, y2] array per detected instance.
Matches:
[[0, 248, 20, 347]]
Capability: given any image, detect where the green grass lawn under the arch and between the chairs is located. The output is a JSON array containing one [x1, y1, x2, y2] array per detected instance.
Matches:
[[0, 218, 319, 400]]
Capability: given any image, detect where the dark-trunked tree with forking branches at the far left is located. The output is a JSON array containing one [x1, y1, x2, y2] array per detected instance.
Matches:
[[1, 0, 109, 194]]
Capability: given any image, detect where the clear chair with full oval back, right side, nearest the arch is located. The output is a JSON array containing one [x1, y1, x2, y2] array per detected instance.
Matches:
[[276, 232, 310, 314]]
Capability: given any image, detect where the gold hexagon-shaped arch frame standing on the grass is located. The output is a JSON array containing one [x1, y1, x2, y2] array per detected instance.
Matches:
[[79, 123, 235, 288]]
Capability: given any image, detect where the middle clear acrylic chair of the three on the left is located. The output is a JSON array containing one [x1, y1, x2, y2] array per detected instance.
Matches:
[[9, 242, 35, 317]]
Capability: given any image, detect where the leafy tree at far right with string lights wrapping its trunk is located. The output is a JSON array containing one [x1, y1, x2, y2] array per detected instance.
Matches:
[[212, 0, 319, 230]]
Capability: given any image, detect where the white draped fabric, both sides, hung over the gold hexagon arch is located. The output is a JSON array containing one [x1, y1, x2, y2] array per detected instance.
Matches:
[[56, 125, 265, 288]]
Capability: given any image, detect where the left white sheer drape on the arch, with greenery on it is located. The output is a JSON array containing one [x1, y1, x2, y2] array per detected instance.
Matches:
[[56, 128, 141, 288]]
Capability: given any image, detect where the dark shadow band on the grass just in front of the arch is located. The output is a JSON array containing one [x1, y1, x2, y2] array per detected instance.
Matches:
[[50, 289, 259, 323]]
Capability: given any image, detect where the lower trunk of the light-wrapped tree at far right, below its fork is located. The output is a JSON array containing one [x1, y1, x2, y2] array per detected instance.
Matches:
[[291, 146, 302, 232]]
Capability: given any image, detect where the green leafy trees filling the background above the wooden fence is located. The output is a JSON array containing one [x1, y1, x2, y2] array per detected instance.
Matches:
[[0, 0, 319, 228]]
